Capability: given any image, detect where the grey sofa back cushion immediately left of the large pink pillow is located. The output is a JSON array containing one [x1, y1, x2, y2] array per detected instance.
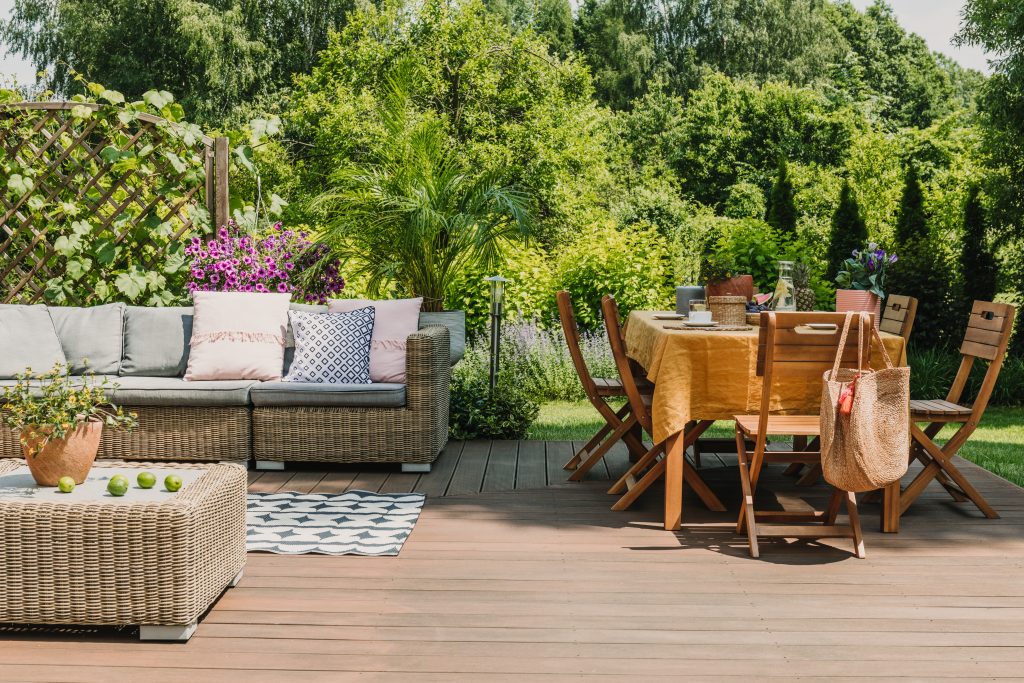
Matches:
[[121, 306, 193, 377]]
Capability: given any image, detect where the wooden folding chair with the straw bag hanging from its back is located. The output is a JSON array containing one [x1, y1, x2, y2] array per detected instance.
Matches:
[[735, 312, 872, 557]]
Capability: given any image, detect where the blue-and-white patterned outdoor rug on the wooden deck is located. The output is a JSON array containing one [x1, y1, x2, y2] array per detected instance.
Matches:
[[246, 490, 426, 555]]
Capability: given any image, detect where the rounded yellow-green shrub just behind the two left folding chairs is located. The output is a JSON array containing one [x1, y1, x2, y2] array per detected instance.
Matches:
[[557, 223, 675, 330]]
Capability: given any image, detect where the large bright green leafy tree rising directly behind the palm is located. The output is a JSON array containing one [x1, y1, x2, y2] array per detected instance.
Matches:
[[285, 0, 618, 246]]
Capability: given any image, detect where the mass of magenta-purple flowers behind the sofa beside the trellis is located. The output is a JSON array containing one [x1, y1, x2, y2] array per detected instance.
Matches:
[[191, 223, 345, 303]]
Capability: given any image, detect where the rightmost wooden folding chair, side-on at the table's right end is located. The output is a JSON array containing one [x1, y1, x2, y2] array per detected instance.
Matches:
[[899, 301, 1016, 519]]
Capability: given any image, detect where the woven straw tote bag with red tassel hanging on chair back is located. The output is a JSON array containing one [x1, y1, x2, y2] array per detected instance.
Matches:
[[821, 311, 910, 493]]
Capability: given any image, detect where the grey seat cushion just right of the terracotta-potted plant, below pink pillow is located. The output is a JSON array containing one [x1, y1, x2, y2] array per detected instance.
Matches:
[[104, 377, 258, 408]]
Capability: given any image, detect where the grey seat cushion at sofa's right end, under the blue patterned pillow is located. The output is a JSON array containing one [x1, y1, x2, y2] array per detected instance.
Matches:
[[249, 382, 406, 408]]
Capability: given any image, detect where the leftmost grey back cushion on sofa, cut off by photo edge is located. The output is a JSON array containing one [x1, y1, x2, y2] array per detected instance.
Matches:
[[0, 304, 67, 379]]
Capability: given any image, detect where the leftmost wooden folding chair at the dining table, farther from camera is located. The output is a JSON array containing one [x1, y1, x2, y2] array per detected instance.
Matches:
[[555, 291, 653, 481]]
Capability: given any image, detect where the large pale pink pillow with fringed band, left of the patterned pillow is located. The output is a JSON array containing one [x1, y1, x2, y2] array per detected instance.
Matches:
[[184, 292, 292, 380]]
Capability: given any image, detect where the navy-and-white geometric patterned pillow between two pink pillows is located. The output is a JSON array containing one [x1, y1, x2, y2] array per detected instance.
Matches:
[[285, 306, 374, 384]]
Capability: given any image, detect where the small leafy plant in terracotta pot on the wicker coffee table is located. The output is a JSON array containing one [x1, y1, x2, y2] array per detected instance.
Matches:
[[0, 365, 138, 486]]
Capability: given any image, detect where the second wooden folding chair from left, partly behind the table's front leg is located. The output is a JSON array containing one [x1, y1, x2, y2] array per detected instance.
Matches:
[[601, 296, 725, 512]]
